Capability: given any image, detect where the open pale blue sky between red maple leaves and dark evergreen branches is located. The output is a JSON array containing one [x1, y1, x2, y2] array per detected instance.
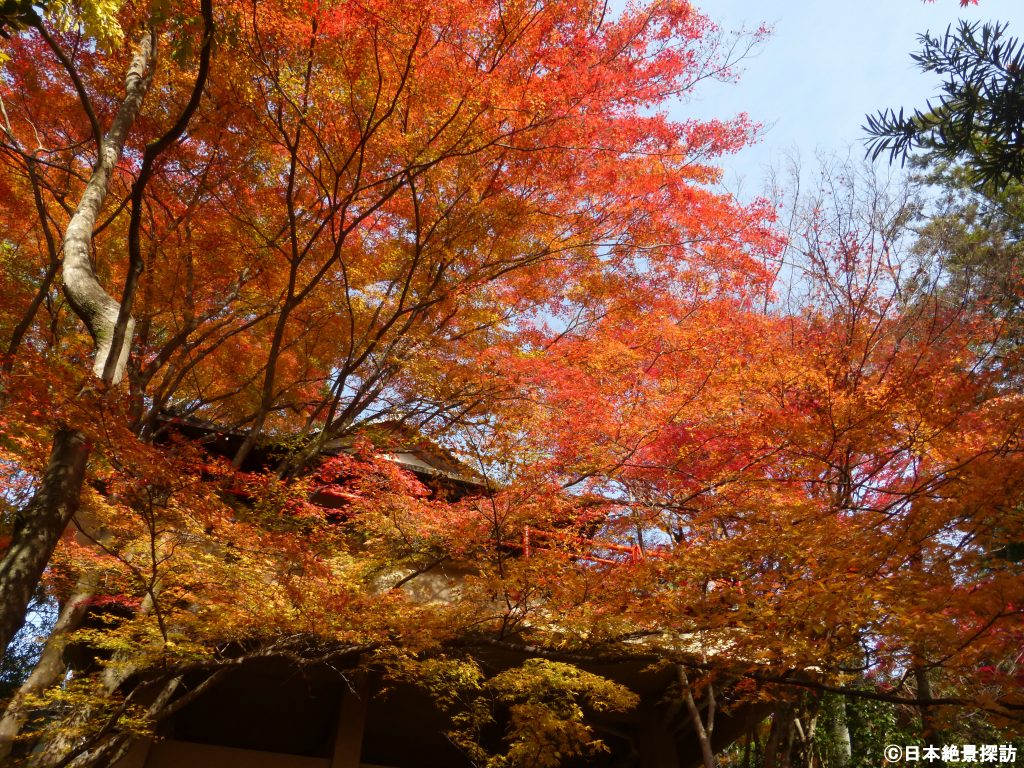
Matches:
[[673, 0, 1024, 197]]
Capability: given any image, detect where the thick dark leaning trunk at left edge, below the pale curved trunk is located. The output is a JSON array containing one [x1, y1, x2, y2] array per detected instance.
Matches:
[[0, 427, 90, 650]]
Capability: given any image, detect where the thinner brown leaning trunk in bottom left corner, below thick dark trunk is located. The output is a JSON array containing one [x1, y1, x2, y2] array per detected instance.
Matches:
[[0, 570, 99, 764]]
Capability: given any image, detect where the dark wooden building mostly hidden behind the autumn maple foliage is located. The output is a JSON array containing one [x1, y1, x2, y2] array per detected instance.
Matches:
[[83, 419, 767, 768]]
